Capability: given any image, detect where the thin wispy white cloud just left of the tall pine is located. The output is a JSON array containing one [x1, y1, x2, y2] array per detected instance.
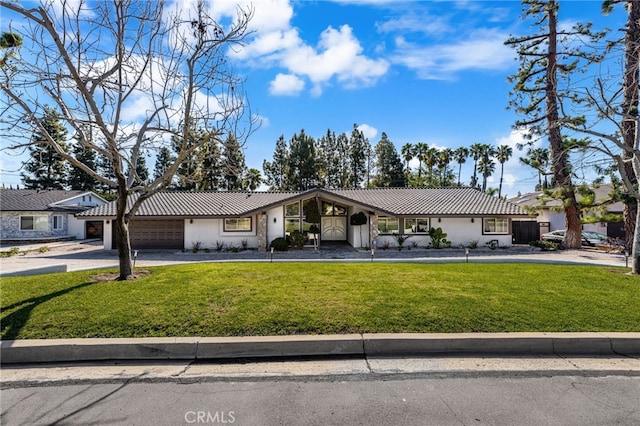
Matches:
[[393, 30, 514, 80]]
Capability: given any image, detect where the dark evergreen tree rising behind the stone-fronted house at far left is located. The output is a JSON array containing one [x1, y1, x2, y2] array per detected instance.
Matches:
[[21, 108, 68, 189]]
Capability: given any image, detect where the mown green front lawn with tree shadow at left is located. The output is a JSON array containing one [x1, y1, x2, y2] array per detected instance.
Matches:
[[1, 263, 640, 339]]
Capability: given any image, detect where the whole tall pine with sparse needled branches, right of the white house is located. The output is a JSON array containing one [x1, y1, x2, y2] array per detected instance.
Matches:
[[505, 0, 604, 248]]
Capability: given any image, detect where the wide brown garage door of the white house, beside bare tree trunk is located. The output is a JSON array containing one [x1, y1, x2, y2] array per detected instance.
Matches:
[[112, 219, 184, 250]]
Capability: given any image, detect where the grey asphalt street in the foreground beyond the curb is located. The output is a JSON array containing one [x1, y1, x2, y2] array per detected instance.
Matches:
[[0, 376, 640, 426]]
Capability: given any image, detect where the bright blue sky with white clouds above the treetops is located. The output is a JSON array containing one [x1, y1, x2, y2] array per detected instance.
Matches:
[[2, 0, 625, 196]]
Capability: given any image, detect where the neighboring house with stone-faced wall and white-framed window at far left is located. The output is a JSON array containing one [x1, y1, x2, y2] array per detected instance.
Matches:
[[0, 189, 107, 243]]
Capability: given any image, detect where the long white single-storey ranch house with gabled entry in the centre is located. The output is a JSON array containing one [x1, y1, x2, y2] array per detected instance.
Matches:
[[78, 188, 529, 250]]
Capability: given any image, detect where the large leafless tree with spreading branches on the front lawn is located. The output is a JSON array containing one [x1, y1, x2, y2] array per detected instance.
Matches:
[[0, 0, 253, 279]]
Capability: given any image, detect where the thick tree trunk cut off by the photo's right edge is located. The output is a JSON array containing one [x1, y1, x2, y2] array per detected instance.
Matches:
[[622, 1, 640, 253]]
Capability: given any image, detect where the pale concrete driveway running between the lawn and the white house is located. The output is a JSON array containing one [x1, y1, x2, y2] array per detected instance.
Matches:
[[0, 241, 626, 274]]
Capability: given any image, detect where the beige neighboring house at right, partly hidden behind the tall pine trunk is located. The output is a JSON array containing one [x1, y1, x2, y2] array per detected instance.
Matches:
[[509, 185, 624, 238]]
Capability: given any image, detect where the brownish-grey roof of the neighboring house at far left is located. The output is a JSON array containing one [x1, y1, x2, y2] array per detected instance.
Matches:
[[0, 189, 87, 211]]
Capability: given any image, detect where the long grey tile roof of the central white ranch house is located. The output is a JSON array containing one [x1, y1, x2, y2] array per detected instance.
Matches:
[[78, 188, 527, 217]]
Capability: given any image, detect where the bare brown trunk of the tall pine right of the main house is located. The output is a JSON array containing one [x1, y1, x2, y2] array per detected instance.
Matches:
[[545, 1, 582, 248]]
